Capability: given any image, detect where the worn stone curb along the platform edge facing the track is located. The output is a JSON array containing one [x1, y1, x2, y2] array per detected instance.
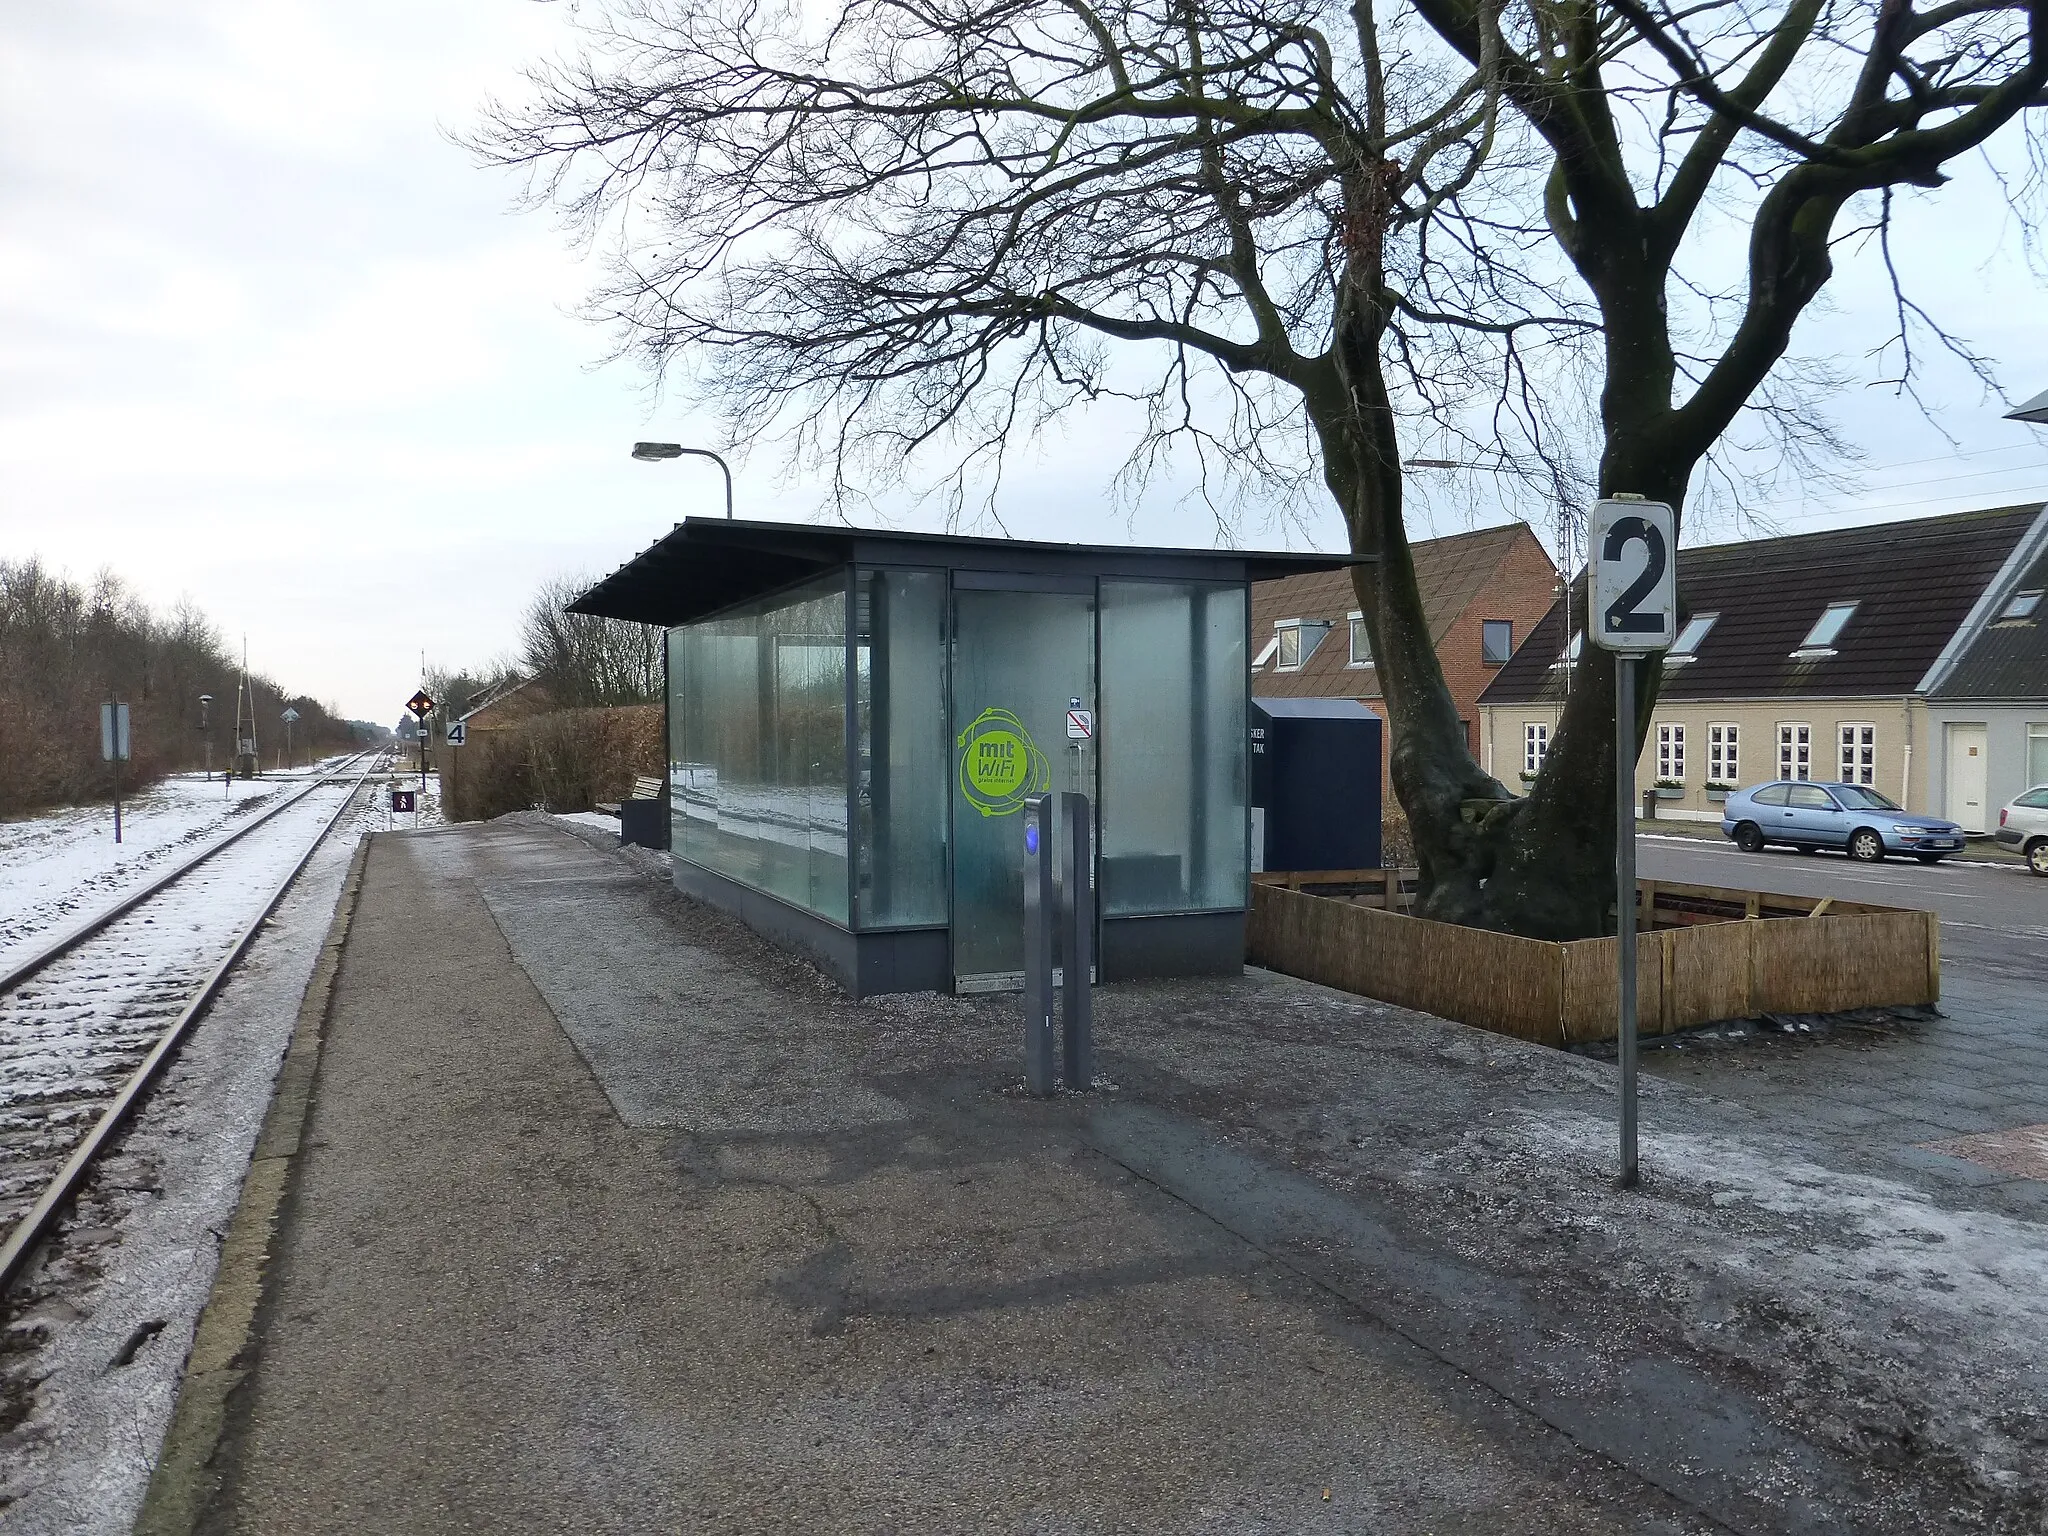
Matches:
[[135, 834, 375, 1536]]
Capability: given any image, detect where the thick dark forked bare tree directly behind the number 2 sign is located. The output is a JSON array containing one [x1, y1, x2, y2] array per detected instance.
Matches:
[[1415, 0, 2048, 936]]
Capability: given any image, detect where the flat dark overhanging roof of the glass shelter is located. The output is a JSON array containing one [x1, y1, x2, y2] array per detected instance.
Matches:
[[569, 518, 1360, 625]]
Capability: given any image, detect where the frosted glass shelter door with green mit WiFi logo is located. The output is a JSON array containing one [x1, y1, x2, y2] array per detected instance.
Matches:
[[952, 590, 1096, 991]]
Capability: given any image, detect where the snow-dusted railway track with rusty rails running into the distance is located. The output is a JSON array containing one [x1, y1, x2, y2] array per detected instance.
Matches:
[[0, 752, 383, 1292]]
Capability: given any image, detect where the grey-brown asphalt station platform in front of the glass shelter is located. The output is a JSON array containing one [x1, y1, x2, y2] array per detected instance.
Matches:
[[143, 817, 2048, 1536]]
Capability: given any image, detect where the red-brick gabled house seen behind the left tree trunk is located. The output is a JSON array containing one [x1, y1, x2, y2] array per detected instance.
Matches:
[[1251, 522, 1559, 805]]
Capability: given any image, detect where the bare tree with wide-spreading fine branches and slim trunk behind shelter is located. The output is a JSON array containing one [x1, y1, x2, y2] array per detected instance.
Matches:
[[477, 0, 1593, 915]]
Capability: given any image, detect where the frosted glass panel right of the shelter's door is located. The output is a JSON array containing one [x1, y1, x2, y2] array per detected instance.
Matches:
[[1098, 582, 1249, 918]]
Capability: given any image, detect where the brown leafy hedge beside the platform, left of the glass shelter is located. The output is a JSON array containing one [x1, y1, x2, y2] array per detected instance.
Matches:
[[442, 705, 666, 821]]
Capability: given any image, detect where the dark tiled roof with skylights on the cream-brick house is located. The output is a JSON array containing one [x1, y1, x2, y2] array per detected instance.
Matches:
[[1479, 502, 2042, 705]]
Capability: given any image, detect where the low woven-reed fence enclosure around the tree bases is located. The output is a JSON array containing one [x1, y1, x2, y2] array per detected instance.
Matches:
[[1245, 870, 1942, 1047]]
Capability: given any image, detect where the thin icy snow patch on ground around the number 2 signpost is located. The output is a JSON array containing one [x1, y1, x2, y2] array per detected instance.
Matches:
[[1438, 1094, 2048, 1515]]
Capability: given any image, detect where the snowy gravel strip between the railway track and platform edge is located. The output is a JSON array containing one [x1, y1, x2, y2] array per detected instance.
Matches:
[[0, 784, 385, 1536]]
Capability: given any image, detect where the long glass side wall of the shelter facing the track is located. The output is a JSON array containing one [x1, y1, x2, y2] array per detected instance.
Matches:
[[670, 573, 846, 924]]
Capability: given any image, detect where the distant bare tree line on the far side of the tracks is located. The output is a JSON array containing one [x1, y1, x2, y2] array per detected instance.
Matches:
[[0, 559, 377, 815]]
